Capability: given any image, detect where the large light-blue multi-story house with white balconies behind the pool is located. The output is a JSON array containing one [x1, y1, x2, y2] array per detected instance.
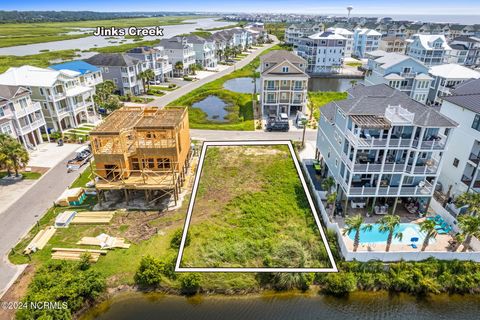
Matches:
[[317, 84, 456, 213]]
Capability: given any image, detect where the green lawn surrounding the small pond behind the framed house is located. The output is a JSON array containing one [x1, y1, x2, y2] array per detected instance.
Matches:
[[169, 45, 283, 131]]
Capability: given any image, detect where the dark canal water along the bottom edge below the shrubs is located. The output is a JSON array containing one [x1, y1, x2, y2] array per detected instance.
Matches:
[[82, 292, 480, 320]]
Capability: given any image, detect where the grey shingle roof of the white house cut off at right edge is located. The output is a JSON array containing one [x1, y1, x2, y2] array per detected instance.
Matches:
[[442, 79, 480, 113]]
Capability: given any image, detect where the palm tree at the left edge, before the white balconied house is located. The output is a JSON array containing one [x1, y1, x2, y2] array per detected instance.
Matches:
[[0, 133, 30, 177]]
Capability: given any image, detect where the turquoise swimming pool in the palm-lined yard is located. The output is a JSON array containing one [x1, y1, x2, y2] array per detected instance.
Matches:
[[348, 223, 435, 244]]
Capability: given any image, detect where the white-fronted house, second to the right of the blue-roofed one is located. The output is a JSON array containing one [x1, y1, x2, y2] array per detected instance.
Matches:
[[127, 46, 173, 83]]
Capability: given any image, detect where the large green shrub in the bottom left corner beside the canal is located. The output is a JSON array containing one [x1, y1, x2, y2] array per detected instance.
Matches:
[[16, 261, 106, 320]]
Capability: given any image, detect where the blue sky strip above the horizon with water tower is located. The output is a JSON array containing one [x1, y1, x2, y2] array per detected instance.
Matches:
[[0, 0, 480, 15]]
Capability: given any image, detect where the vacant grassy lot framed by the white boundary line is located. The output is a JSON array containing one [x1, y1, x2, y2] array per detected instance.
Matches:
[[178, 145, 331, 268]]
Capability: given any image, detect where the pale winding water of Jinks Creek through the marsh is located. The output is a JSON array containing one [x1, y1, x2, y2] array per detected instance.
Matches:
[[0, 18, 234, 56]]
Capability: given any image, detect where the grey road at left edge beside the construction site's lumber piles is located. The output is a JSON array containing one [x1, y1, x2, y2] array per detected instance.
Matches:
[[0, 153, 86, 296]]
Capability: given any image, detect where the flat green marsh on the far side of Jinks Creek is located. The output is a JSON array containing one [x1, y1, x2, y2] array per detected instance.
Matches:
[[0, 16, 205, 47]]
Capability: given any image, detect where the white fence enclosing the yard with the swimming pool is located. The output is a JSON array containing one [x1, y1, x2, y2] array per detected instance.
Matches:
[[301, 160, 480, 262]]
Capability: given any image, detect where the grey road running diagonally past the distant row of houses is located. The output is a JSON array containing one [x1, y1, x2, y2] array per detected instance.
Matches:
[[148, 36, 278, 107]]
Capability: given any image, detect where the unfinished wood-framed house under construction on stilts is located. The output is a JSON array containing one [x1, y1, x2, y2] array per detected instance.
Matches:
[[90, 106, 191, 204]]
